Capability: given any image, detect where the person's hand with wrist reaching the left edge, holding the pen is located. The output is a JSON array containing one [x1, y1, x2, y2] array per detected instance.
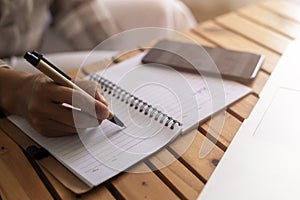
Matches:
[[0, 69, 109, 136]]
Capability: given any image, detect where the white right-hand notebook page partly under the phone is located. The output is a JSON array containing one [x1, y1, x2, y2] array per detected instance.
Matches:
[[98, 53, 251, 133]]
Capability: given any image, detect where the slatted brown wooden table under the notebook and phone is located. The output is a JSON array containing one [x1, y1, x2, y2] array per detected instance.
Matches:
[[0, 1, 300, 200]]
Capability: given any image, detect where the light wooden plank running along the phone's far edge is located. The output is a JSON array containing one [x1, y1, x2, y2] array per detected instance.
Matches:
[[193, 21, 280, 73]]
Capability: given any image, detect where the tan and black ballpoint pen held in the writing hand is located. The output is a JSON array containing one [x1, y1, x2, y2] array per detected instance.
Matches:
[[24, 51, 124, 127]]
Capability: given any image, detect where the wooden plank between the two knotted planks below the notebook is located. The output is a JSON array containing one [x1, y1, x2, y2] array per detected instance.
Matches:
[[147, 149, 204, 199]]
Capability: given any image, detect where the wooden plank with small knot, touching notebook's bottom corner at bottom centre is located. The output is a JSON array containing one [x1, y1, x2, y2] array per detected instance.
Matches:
[[111, 163, 179, 199]]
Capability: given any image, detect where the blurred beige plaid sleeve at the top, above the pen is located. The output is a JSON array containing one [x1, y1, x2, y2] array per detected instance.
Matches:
[[51, 0, 119, 50]]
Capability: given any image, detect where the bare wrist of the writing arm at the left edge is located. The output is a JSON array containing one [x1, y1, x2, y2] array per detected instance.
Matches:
[[0, 67, 30, 115]]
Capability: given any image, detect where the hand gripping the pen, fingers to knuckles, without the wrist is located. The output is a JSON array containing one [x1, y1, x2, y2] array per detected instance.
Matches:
[[22, 74, 109, 136]]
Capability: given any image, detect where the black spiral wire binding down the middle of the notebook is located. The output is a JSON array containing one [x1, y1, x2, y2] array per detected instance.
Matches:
[[90, 74, 182, 129]]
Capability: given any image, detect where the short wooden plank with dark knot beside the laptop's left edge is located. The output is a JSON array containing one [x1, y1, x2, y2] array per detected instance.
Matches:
[[170, 131, 224, 182]]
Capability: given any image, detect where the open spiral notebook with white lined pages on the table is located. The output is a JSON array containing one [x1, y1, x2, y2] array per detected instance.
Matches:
[[9, 54, 251, 187]]
